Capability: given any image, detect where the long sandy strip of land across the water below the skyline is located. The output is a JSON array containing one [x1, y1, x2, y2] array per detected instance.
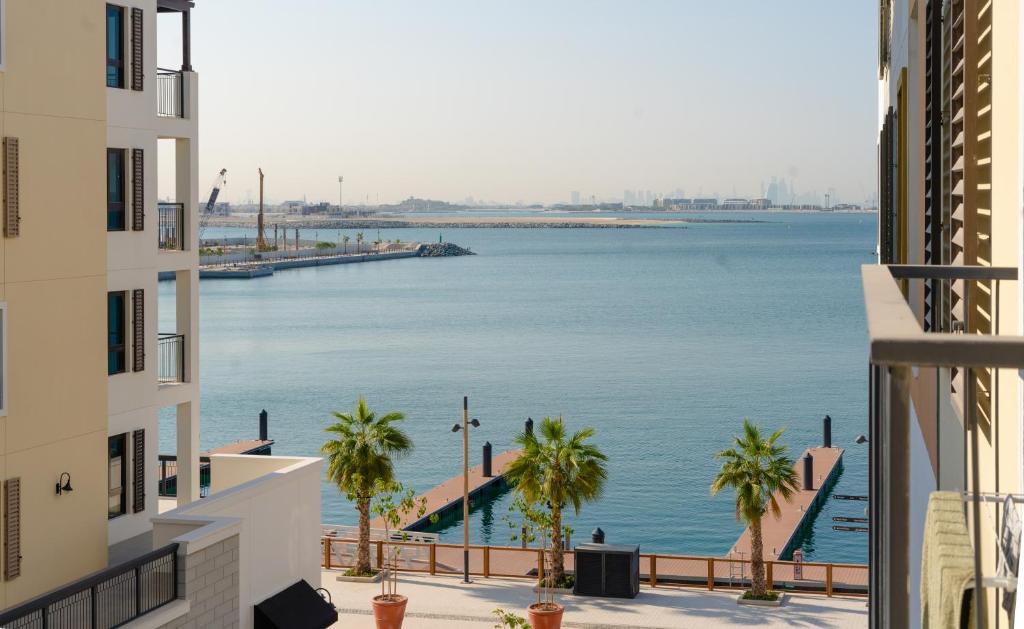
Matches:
[[209, 214, 763, 229]]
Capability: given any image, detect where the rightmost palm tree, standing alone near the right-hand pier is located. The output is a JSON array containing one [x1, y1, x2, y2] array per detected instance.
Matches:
[[711, 419, 799, 597]]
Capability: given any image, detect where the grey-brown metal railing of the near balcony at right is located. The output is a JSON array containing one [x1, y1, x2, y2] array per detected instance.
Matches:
[[861, 264, 1024, 628]]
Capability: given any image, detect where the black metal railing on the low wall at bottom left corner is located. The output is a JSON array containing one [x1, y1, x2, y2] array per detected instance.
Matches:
[[0, 544, 178, 629]]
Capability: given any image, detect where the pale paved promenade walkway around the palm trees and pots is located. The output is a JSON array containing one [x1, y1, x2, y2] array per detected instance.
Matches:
[[323, 571, 867, 629]]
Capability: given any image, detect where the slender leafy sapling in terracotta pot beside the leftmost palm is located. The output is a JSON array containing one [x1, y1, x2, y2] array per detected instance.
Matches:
[[374, 480, 427, 629]]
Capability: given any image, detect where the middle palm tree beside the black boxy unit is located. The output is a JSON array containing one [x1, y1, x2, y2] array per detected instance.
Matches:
[[505, 417, 608, 585]]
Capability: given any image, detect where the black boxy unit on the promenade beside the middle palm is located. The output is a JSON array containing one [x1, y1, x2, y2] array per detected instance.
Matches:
[[572, 544, 640, 598]]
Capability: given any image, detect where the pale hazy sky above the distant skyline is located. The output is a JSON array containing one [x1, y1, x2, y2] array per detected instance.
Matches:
[[160, 0, 877, 204]]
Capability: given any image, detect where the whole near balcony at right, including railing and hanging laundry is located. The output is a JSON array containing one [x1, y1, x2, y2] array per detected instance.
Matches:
[[861, 264, 1024, 628]]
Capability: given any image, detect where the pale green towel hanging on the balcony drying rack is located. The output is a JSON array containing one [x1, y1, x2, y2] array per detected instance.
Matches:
[[921, 492, 974, 629]]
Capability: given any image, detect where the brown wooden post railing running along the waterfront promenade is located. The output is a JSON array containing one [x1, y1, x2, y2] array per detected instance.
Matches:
[[321, 536, 867, 596]]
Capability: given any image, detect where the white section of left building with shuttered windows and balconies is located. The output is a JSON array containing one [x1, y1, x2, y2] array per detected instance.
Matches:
[[106, 0, 199, 545]]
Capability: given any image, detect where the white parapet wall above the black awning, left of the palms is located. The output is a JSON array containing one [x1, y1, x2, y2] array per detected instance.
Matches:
[[153, 455, 322, 627]]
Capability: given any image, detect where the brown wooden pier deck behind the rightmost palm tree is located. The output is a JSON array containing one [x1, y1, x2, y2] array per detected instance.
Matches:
[[729, 448, 844, 559]]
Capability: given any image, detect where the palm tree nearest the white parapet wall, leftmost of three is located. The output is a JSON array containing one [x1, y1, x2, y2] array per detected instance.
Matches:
[[321, 397, 413, 575]]
